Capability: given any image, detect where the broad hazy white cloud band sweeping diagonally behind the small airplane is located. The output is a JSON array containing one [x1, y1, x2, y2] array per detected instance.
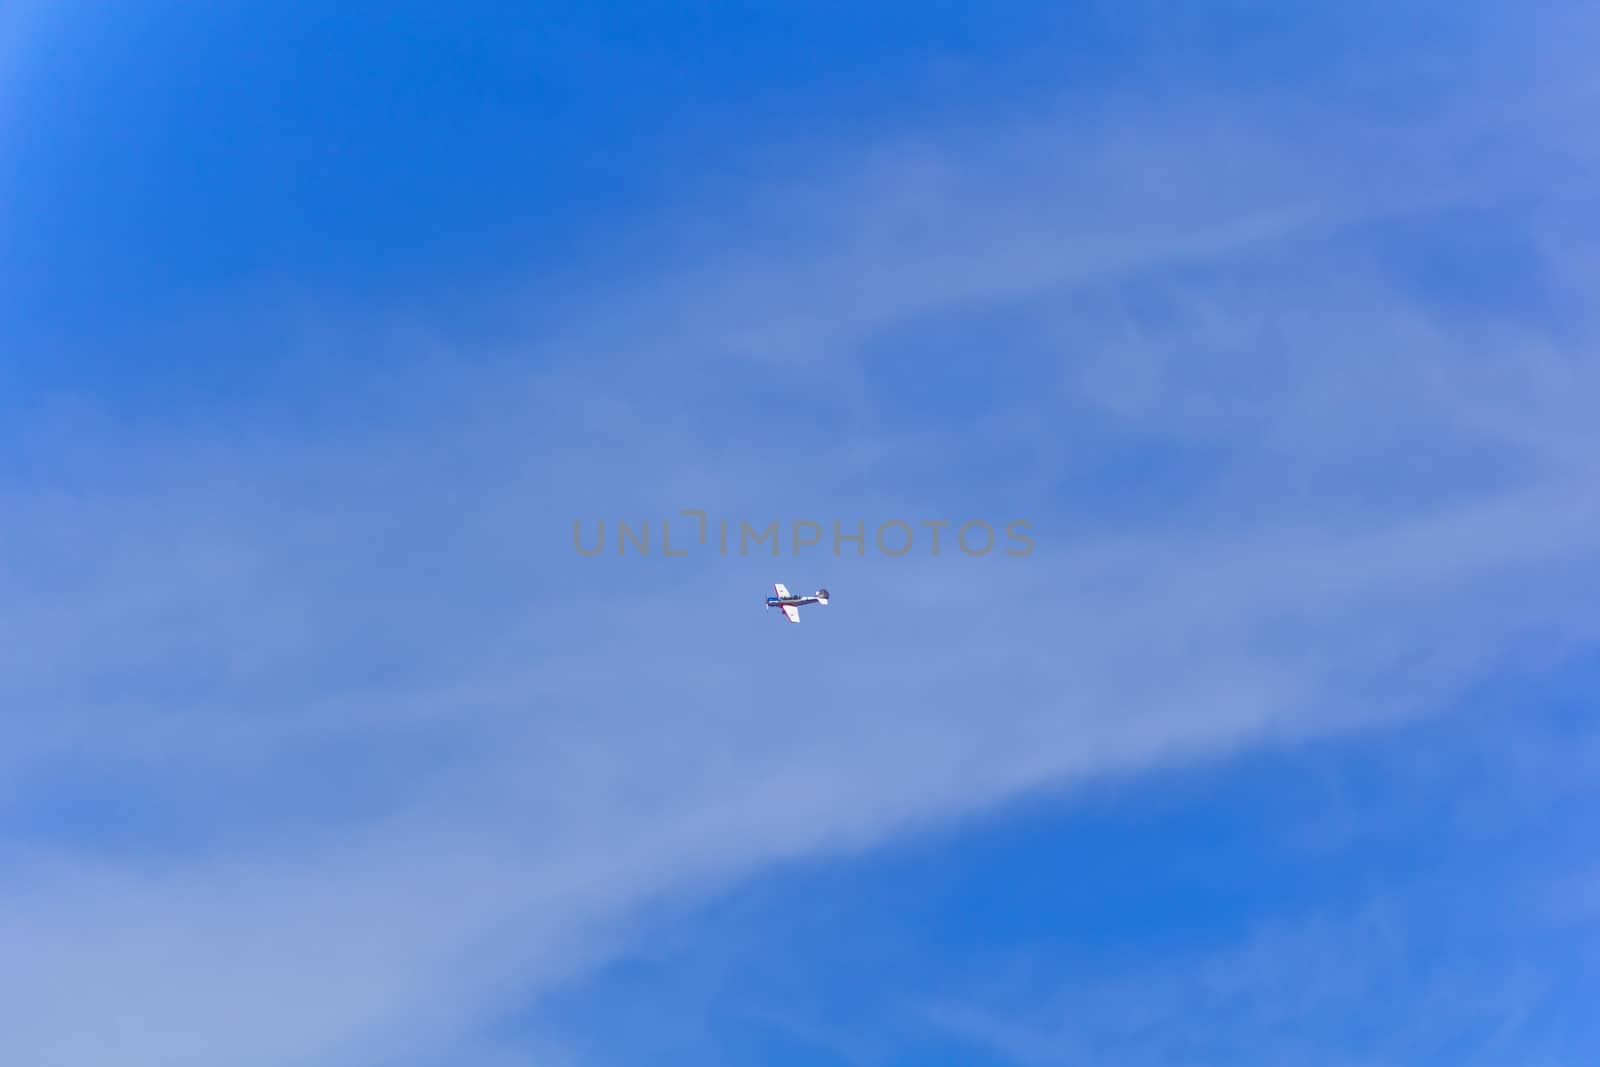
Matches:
[[0, 6, 1600, 1067]]
